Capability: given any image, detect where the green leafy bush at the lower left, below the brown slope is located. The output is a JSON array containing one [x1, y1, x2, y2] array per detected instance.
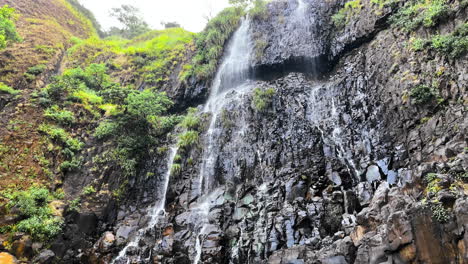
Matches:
[[3, 187, 63, 241]]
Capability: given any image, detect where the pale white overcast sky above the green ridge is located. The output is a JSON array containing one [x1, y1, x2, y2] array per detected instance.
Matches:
[[79, 0, 228, 32]]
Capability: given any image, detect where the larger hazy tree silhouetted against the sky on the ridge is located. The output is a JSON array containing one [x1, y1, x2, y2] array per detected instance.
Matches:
[[109, 5, 150, 39]]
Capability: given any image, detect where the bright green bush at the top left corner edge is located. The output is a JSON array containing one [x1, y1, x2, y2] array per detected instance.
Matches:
[[0, 5, 22, 50]]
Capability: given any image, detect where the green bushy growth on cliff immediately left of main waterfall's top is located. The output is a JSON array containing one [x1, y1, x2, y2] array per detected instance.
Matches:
[[179, 7, 244, 80]]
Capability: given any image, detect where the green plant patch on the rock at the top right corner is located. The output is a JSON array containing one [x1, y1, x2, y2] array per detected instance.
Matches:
[[390, 0, 450, 32]]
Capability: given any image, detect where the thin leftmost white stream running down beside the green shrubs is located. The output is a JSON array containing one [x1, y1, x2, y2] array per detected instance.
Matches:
[[112, 146, 178, 263]]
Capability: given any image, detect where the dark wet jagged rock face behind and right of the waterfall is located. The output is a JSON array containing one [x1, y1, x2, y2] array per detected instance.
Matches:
[[56, 0, 468, 264]]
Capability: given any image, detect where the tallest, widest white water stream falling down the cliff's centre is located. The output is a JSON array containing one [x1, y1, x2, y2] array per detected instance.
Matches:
[[192, 19, 252, 264]]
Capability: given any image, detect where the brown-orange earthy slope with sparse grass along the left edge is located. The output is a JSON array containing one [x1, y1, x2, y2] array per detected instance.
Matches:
[[0, 0, 95, 200]]
